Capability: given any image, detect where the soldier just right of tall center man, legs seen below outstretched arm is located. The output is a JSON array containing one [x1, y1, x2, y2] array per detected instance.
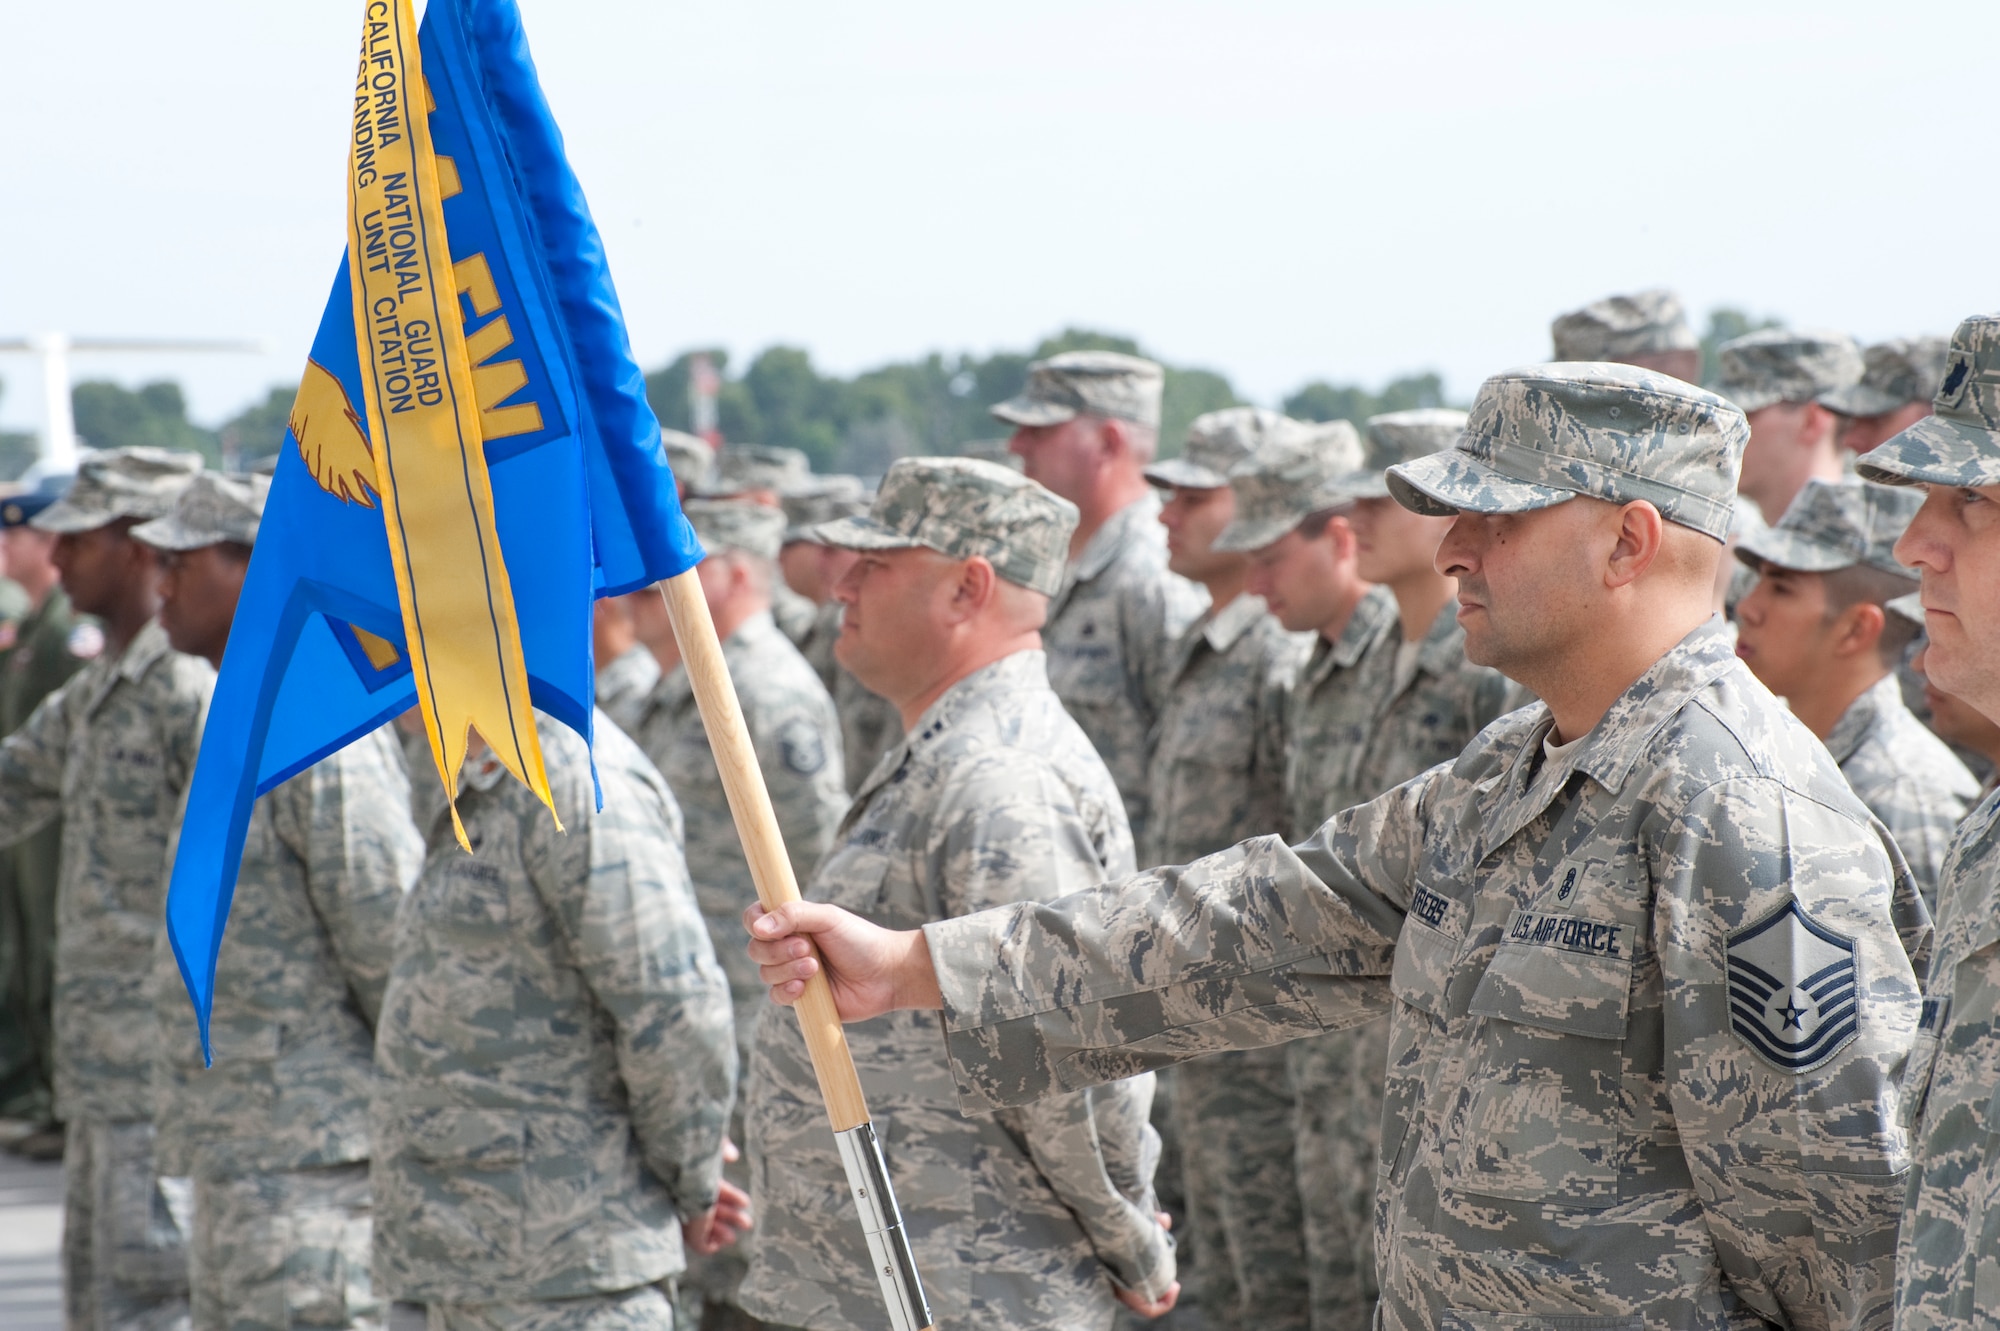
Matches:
[[1138, 408, 1312, 1331]]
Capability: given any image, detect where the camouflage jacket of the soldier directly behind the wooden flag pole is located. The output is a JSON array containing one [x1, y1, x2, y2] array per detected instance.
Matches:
[[632, 614, 848, 1057]]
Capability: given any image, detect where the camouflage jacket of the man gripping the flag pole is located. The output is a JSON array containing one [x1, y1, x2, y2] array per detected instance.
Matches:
[[926, 622, 1930, 1331]]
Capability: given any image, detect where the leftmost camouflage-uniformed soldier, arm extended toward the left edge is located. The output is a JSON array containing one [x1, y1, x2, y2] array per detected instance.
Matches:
[[0, 448, 214, 1331]]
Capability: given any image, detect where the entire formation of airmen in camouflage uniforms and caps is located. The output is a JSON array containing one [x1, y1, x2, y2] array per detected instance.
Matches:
[[0, 292, 2000, 1331]]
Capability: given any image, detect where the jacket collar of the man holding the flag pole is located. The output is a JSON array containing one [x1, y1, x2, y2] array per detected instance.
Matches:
[[1484, 618, 1738, 847]]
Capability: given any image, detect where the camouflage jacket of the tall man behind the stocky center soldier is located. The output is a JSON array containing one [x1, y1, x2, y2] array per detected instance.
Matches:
[[1042, 492, 1208, 843]]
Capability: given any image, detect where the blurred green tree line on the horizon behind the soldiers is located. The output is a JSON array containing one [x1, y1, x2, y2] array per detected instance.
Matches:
[[0, 308, 1776, 480]]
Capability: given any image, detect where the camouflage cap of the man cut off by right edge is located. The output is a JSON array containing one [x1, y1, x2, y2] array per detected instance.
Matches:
[[1856, 314, 2000, 486]]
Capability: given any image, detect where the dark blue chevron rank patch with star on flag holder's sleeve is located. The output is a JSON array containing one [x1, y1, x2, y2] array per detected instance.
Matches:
[[1730, 899, 1860, 1073]]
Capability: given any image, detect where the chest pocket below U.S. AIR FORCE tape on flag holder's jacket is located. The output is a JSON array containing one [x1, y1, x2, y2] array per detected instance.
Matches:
[[1448, 911, 1632, 1209]]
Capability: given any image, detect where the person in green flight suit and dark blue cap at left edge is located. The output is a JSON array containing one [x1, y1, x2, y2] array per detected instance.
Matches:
[[0, 482, 93, 1159]]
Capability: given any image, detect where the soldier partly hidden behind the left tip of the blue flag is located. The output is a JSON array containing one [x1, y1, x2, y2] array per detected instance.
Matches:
[[132, 472, 424, 1331]]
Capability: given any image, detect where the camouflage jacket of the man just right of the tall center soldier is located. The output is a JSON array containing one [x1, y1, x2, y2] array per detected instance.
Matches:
[[1140, 594, 1310, 867]]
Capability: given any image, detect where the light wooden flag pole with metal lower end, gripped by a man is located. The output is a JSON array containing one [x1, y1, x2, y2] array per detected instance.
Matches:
[[660, 568, 932, 1331]]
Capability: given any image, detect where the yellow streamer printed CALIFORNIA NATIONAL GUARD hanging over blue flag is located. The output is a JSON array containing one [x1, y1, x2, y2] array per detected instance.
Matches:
[[348, 0, 560, 849]]
